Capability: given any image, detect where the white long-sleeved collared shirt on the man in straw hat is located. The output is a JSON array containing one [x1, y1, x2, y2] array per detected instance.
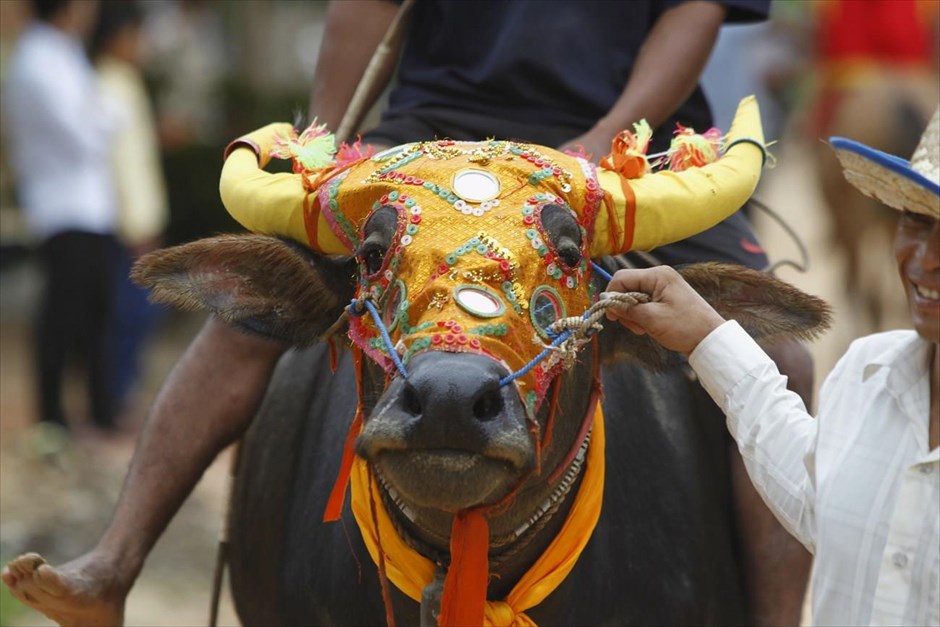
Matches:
[[689, 322, 940, 625]]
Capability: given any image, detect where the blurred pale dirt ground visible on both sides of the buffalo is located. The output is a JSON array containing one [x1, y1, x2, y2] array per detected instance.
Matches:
[[0, 136, 904, 625]]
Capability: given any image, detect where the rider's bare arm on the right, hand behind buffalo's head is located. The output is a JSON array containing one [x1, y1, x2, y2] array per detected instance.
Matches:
[[563, 0, 727, 161]]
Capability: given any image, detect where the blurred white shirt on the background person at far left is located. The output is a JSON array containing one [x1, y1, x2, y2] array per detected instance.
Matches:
[[3, 22, 117, 238]]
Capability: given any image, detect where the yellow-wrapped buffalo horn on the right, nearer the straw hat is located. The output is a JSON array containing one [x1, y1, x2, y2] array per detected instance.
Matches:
[[592, 96, 764, 257]]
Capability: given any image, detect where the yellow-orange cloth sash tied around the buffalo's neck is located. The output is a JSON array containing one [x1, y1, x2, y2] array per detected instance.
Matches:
[[350, 403, 605, 627]]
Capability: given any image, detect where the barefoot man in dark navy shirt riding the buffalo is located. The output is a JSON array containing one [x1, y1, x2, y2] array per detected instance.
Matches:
[[3, 0, 812, 624]]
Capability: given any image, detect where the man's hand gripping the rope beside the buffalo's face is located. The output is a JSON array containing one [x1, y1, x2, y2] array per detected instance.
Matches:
[[607, 266, 725, 355]]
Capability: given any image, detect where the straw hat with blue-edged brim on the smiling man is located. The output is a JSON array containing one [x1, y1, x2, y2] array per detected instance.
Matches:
[[829, 108, 940, 219]]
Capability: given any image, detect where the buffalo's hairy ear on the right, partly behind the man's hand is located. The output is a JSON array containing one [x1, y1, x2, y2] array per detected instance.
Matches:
[[601, 262, 832, 370]]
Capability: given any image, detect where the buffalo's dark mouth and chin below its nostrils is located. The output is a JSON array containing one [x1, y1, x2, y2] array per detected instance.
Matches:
[[373, 449, 524, 512]]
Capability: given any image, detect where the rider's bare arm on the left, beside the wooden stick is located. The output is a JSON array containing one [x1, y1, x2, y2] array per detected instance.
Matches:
[[310, 0, 401, 140]]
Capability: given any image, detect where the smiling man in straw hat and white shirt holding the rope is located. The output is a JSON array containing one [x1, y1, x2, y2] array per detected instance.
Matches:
[[608, 109, 940, 625]]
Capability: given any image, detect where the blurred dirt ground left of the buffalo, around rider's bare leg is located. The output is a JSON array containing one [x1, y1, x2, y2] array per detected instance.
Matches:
[[0, 300, 238, 626]]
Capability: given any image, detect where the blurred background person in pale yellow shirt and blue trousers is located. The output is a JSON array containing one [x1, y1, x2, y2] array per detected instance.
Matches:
[[90, 0, 169, 422]]
